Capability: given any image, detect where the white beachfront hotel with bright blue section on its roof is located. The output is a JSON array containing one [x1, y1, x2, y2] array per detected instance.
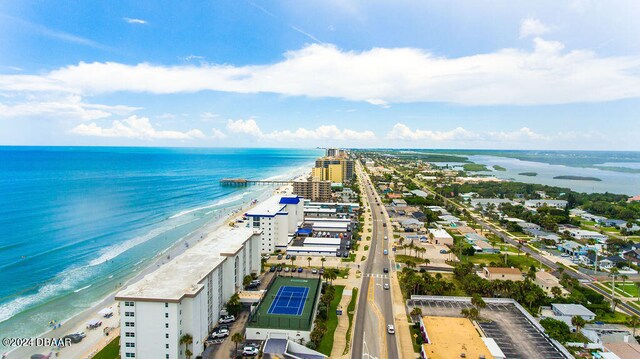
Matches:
[[245, 195, 304, 253]]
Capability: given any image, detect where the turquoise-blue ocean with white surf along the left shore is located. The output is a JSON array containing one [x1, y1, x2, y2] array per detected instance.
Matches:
[[0, 147, 321, 346]]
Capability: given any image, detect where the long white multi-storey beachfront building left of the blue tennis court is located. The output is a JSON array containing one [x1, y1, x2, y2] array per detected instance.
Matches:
[[116, 228, 260, 359]]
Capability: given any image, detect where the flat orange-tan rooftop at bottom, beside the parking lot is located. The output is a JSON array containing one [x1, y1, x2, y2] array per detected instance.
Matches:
[[422, 316, 493, 359]]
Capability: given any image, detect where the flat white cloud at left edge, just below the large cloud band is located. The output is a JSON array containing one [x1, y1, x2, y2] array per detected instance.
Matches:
[[0, 95, 141, 121]]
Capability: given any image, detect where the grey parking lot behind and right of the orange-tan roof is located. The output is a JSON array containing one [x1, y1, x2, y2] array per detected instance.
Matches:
[[407, 299, 565, 359]]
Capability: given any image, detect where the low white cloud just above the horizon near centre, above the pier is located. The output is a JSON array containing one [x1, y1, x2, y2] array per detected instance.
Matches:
[[227, 119, 376, 141]]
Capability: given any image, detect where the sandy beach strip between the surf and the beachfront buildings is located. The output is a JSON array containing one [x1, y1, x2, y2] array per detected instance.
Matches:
[[6, 186, 290, 359]]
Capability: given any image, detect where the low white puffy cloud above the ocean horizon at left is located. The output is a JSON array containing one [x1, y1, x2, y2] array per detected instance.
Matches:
[[71, 116, 206, 140]]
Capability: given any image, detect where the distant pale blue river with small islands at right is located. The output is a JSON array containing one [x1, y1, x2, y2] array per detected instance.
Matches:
[[468, 155, 640, 195]]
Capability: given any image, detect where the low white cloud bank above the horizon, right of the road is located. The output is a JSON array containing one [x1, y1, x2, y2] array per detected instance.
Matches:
[[386, 123, 551, 144]]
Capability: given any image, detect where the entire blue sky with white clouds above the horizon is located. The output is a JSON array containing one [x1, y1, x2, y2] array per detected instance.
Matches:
[[0, 0, 640, 150]]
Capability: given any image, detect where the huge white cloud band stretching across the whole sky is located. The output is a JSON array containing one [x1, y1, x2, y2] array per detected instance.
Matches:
[[5, 40, 640, 106]]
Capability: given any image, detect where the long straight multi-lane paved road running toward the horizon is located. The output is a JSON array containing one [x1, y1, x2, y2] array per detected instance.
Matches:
[[351, 165, 399, 359]]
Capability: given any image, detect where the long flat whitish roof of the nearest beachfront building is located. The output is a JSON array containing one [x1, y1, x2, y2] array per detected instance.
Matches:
[[116, 227, 260, 302]]
